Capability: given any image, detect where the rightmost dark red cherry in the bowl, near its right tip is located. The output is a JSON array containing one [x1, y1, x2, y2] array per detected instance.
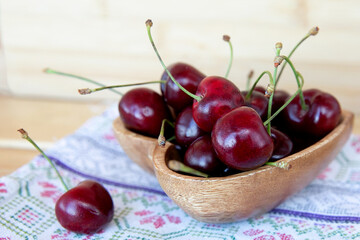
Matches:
[[282, 89, 341, 137]]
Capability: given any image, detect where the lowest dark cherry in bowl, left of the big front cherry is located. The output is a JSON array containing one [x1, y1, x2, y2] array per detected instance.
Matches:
[[184, 135, 224, 175]]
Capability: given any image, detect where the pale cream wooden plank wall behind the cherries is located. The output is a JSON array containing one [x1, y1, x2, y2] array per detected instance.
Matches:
[[0, 0, 360, 113]]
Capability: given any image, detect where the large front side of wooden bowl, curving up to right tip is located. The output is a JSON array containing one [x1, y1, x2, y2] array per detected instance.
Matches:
[[153, 111, 354, 223]]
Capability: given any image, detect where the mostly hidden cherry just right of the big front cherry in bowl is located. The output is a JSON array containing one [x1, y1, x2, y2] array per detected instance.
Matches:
[[270, 128, 293, 161]]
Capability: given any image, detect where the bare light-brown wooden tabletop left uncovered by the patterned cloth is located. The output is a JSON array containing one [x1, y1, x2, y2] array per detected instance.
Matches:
[[0, 95, 360, 176]]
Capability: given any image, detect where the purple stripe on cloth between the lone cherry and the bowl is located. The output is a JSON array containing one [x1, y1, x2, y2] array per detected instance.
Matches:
[[45, 156, 167, 196]]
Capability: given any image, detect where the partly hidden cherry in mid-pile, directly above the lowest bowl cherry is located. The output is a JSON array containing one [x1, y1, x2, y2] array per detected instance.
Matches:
[[175, 106, 205, 147]]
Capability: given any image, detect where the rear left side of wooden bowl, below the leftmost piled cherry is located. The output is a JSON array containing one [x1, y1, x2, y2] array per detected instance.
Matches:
[[113, 117, 158, 174]]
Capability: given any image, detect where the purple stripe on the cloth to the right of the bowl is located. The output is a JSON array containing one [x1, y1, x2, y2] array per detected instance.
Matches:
[[270, 208, 360, 222]]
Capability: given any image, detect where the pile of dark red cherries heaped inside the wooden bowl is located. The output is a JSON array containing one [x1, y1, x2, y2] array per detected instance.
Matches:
[[119, 20, 341, 176]]
